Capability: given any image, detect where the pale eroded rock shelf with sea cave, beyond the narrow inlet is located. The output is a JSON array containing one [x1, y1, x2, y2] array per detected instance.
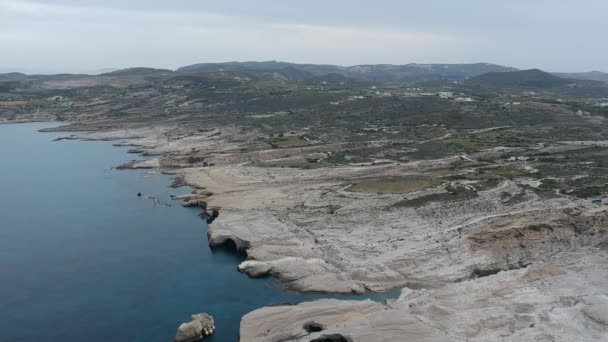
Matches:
[[176, 163, 607, 292]]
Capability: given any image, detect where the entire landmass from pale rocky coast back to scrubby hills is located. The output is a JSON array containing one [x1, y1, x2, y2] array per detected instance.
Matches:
[[5, 62, 608, 342]]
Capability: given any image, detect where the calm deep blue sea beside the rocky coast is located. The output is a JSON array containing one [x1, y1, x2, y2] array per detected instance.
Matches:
[[0, 124, 400, 342]]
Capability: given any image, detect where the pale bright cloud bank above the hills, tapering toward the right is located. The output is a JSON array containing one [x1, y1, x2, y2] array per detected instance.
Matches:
[[0, 0, 466, 71]]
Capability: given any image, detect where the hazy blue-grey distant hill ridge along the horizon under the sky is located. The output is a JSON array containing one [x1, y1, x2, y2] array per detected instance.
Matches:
[[7, 61, 608, 87]]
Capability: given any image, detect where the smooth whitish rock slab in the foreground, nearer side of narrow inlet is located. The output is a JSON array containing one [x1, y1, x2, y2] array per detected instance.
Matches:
[[241, 249, 608, 342]]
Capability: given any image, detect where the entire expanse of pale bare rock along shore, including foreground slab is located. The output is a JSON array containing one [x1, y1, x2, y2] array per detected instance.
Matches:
[[53, 127, 608, 342]]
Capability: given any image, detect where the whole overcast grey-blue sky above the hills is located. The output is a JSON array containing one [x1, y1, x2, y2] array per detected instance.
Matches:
[[0, 0, 608, 72]]
